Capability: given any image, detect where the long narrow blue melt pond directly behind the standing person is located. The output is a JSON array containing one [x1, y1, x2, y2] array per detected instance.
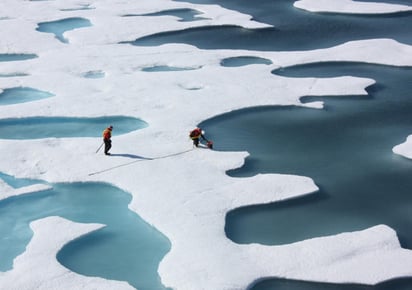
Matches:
[[0, 116, 148, 139]]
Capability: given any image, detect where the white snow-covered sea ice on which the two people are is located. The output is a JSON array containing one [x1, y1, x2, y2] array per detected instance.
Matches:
[[0, 0, 412, 290]]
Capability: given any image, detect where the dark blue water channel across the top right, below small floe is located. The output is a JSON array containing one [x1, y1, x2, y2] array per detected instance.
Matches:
[[128, 0, 412, 51]]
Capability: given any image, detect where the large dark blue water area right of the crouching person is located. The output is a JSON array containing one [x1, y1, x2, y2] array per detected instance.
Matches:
[[200, 62, 412, 290]]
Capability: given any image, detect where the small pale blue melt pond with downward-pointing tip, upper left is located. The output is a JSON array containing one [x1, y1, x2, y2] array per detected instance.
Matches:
[[36, 17, 92, 43]]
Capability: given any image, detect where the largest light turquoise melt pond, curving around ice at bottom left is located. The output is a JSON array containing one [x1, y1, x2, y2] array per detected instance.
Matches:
[[0, 174, 170, 290]]
